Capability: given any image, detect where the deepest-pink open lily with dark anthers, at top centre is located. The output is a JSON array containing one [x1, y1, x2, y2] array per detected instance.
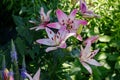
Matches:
[[47, 9, 87, 40]]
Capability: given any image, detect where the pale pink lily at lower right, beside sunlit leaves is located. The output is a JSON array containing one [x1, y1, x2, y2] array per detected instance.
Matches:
[[80, 41, 101, 74]]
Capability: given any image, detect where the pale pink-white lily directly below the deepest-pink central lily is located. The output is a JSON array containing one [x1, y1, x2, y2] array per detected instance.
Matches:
[[36, 28, 74, 52]]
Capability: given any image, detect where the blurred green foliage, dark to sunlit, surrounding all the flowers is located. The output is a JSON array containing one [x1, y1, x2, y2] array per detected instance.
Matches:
[[0, 0, 120, 80]]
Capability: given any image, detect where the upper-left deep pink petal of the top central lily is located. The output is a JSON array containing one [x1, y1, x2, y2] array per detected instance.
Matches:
[[56, 9, 68, 24]]
